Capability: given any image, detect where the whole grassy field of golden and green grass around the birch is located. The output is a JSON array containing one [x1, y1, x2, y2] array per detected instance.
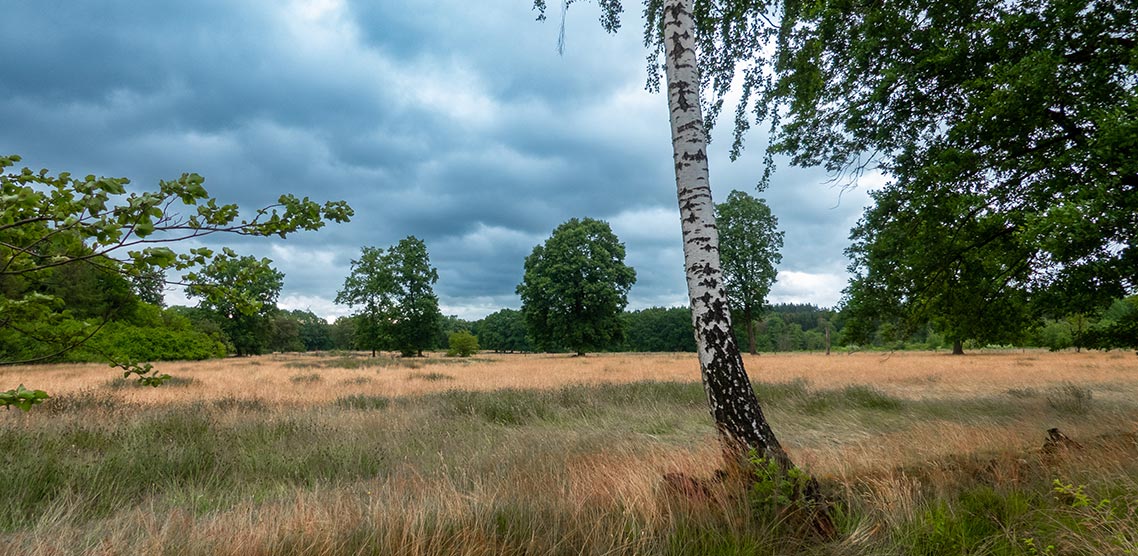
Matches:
[[0, 351, 1138, 555]]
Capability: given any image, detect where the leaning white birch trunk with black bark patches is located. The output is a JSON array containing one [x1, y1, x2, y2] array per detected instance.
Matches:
[[663, 0, 792, 468]]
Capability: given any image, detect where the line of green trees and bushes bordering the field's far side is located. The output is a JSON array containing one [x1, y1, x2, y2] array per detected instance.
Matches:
[[0, 152, 1138, 362]]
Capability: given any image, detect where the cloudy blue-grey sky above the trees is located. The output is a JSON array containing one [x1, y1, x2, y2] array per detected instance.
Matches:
[[0, 0, 877, 320]]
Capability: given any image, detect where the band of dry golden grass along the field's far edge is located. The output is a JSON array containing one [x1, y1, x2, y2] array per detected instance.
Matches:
[[0, 350, 1138, 405]]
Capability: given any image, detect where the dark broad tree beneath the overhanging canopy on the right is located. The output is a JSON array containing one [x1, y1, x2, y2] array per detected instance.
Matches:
[[846, 185, 1034, 355]]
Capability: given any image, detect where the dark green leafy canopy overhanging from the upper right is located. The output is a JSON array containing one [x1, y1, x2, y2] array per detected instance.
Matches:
[[538, 0, 1138, 310]]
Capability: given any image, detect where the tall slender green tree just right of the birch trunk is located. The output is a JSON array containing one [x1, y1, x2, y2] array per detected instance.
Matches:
[[716, 191, 784, 354]]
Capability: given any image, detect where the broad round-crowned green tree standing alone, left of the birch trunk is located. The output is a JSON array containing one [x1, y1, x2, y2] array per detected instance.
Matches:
[[518, 218, 636, 355]]
